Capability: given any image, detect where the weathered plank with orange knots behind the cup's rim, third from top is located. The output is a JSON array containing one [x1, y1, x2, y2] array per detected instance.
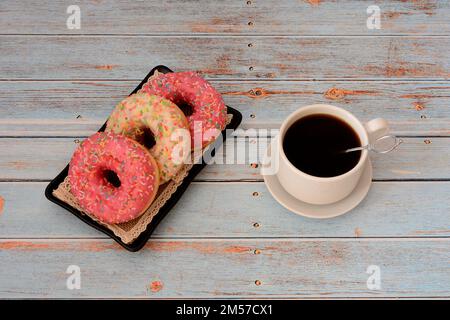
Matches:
[[0, 81, 450, 136]]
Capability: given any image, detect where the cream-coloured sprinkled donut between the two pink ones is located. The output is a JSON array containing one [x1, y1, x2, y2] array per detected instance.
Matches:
[[105, 93, 191, 184]]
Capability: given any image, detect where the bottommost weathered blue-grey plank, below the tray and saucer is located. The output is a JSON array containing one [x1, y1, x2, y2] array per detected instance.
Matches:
[[0, 239, 450, 298]]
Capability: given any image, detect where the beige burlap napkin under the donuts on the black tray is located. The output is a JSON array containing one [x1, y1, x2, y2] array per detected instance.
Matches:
[[53, 114, 233, 244]]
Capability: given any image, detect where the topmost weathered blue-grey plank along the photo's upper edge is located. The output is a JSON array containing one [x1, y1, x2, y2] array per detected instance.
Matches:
[[0, 0, 450, 35]]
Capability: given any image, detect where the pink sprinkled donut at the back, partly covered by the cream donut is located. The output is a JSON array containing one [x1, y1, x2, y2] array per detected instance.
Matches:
[[141, 71, 227, 149]]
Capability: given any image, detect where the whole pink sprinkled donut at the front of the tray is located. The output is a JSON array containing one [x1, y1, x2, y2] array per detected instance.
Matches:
[[69, 132, 159, 223]]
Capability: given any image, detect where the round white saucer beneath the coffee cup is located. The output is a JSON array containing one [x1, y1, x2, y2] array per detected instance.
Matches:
[[262, 144, 372, 219]]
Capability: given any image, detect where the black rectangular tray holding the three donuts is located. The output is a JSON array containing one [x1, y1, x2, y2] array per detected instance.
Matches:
[[45, 65, 242, 252]]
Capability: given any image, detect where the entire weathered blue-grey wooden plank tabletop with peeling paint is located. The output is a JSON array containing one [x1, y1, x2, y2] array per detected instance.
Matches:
[[0, 0, 450, 298]]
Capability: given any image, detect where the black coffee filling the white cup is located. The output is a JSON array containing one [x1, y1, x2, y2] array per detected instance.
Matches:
[[283, 114, 361, 177]]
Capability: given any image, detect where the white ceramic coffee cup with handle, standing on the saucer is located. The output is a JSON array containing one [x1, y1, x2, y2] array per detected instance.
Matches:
[[271, 104, 389, 205]]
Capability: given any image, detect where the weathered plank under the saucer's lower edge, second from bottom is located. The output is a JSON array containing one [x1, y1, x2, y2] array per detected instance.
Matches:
[[0, 181, 450, 239]]
